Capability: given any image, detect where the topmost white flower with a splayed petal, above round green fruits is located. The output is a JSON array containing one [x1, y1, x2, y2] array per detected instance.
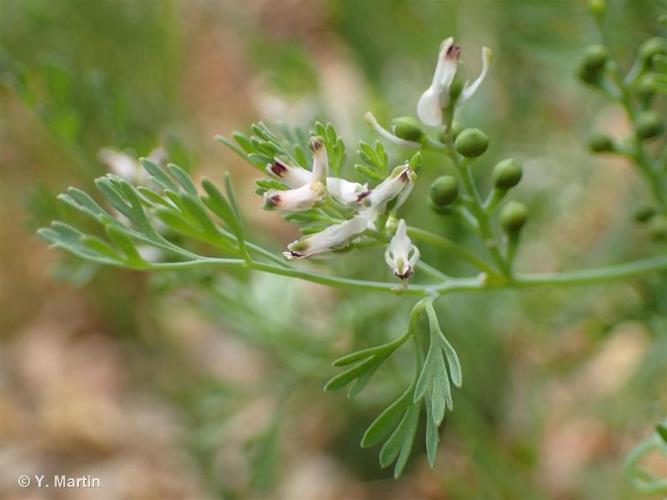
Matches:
[[417, 37, 492, 127]]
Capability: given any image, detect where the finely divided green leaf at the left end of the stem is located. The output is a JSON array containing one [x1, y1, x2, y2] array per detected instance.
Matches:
[[39, 160, 258, 268]]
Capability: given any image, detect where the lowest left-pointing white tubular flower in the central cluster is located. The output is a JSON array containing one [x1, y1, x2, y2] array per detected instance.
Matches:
[[283, 215, 367, 259]]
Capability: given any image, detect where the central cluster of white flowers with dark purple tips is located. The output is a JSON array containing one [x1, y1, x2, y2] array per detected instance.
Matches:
[[264, 137, 419, 279]]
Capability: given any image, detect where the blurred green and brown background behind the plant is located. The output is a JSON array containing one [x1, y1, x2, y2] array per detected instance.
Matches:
[[0, 0, 667, 499]]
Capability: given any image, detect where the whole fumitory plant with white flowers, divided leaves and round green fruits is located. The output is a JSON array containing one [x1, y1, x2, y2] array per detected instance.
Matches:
[[39, 2, 667, 484]]
